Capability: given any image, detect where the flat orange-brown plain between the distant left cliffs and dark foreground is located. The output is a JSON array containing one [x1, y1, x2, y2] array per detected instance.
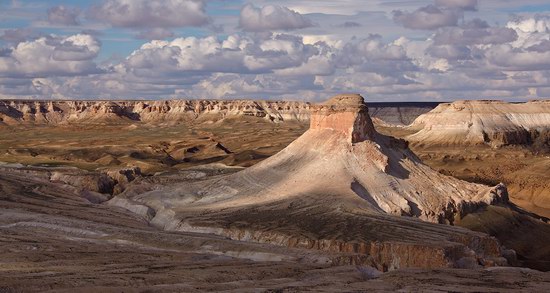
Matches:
[[0, 117, 307, 173]]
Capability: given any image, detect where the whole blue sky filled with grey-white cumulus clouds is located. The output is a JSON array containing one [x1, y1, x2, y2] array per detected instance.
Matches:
[[0, 0, 550, 102]]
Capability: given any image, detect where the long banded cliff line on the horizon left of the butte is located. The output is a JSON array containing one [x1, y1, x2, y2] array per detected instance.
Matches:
[[0, 100, 310, 124]]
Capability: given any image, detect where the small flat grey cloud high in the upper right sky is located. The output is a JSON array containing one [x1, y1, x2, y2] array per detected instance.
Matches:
[[393, 5, 463, 30]]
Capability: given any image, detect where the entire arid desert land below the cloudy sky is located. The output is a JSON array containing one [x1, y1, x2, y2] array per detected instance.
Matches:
[[0, 95, 550, 292]]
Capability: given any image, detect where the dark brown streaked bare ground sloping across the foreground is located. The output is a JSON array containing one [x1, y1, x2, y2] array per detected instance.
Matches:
[[0, 165, 550, 292]]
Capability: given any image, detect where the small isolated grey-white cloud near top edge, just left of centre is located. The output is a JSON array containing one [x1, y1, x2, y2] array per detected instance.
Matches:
[[239, 4, 313, 32]]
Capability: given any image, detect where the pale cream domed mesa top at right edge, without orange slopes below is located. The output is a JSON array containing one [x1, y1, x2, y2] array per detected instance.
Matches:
[[406, 101, 550, 147]]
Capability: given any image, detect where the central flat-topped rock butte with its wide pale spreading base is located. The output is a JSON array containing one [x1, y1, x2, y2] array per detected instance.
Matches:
[[109, 94, 508, 270]]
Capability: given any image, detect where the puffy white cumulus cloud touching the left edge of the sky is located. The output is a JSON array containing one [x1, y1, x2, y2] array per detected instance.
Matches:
[[0, 34, 100, 77]]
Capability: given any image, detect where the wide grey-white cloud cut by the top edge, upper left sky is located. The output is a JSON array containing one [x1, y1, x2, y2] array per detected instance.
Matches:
[[87, 0, 210, 28]]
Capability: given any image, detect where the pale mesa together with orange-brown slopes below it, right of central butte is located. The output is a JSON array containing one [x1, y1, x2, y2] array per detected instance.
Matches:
[[395, 100, 550, 217]]
